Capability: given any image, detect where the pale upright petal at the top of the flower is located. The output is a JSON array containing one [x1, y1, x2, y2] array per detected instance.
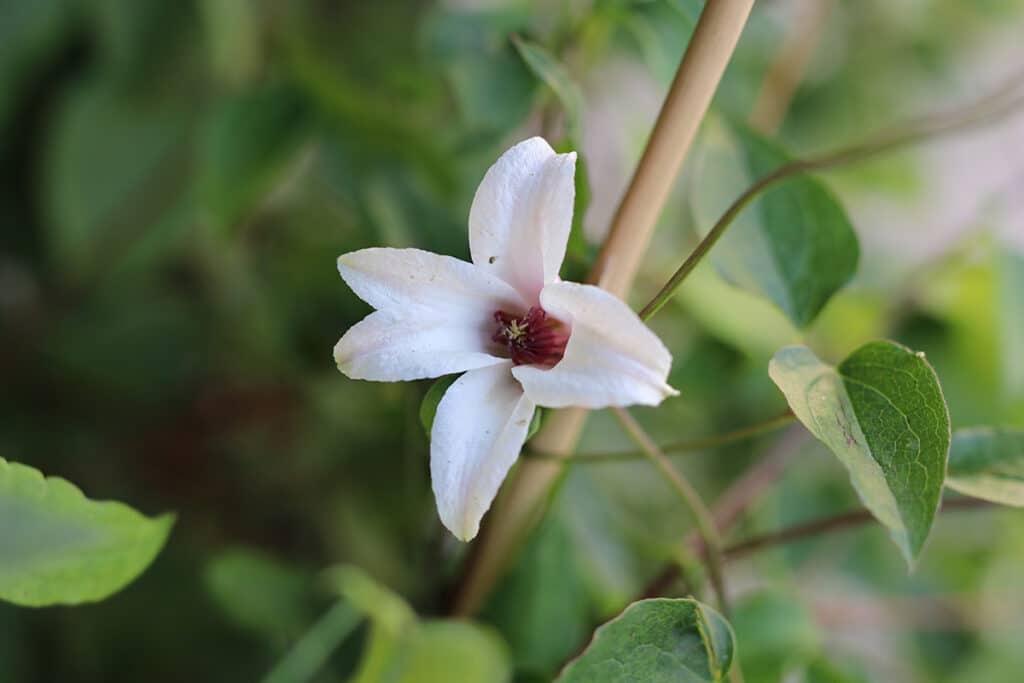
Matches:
[[469, 137, 575, 303]]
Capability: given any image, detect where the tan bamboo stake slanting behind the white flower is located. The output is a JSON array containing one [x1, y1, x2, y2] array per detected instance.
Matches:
[[454, 0, 754, 615]]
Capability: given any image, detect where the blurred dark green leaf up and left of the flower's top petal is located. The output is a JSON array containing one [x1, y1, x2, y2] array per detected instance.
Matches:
[[202, 86, 310, 224]]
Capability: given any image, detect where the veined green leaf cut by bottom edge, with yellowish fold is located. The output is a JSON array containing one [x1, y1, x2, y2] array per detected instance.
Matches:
[[557, 598, 733, 683]]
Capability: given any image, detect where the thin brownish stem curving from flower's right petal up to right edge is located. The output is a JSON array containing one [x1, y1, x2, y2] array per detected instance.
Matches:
[[640, 67, 1024, 321]]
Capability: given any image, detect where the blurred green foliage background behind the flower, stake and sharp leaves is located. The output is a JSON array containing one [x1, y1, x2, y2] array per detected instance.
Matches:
[[0, 0, 1024, 683]]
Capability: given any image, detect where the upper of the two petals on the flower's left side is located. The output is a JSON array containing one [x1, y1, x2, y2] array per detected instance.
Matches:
[[338, 248, 524, 321]]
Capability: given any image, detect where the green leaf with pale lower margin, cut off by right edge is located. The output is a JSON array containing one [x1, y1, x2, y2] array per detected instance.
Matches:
[[946, 427, 1024, 507]]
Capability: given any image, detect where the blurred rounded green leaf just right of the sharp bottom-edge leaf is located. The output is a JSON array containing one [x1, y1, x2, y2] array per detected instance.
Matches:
[[731, 590, 819, 683]]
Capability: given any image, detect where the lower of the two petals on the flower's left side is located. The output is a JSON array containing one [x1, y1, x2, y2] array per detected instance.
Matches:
[[334, 308, 507, 382]]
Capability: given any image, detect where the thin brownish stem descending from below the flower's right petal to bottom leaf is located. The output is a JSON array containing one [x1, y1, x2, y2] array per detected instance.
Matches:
[[611, 408, 729, 616]]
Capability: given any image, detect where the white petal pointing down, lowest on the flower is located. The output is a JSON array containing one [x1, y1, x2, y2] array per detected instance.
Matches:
[[430, 361, 535, 541]]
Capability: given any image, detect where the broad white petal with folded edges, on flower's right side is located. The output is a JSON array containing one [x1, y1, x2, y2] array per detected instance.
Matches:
[[512, 283, 679, 409]]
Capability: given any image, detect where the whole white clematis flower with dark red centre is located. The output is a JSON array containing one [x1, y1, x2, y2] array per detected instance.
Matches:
[[334, 137, 677, 541]]
